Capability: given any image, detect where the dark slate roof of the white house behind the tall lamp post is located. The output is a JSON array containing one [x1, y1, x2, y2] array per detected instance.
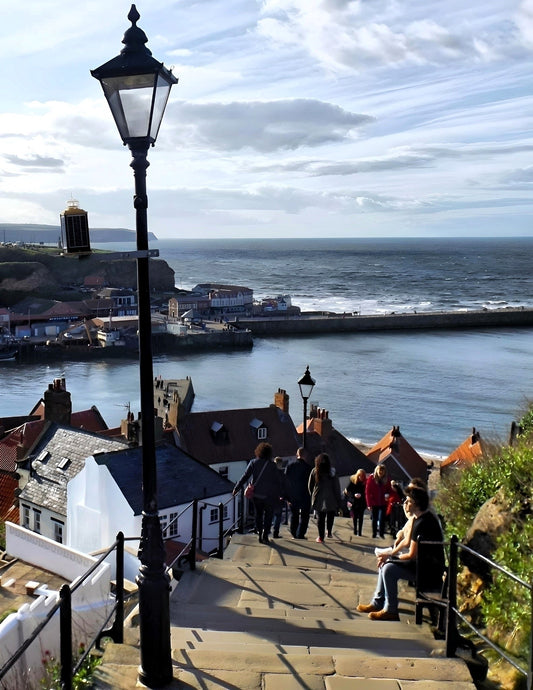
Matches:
[[95, 443, 233, 515]]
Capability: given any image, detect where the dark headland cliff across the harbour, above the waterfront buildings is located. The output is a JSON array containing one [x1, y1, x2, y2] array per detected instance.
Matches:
[[0, 246, 175, 307]]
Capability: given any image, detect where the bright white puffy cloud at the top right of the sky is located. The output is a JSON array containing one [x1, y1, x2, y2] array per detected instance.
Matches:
[[257, 0, 533, 72]]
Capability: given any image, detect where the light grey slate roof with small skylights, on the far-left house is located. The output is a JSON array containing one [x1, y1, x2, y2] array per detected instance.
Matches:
[[20, 423, 126, 516]]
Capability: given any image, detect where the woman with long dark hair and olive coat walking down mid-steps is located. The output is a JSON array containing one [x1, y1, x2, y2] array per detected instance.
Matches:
[[309, 453, 342, 543]]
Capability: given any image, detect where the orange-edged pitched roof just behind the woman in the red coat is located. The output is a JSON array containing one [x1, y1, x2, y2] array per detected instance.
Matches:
[[366, 426, 428, 482]]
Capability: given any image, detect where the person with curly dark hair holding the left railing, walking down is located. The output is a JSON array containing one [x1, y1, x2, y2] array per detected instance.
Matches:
[[233, 443, 283, 544]]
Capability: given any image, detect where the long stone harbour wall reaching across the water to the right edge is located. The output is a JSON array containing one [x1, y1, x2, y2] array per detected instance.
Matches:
[[232, 308, 533, 338]]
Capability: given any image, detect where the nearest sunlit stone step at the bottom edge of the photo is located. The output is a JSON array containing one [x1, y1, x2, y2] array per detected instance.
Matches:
[[94, 644, 475, 690]]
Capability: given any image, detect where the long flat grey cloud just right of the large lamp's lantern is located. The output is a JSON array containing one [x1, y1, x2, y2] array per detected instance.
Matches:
[[167, 98, 373, 153]]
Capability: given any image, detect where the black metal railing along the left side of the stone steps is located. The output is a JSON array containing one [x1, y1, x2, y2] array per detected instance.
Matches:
[[0, 494, 245, 690]]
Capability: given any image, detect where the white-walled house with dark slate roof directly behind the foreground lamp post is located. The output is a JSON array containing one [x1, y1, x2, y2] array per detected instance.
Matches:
[[66, 443, 236, 580]]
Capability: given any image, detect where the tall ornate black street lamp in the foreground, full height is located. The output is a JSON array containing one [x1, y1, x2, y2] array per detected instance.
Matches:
[[91, 5, 178, 688]]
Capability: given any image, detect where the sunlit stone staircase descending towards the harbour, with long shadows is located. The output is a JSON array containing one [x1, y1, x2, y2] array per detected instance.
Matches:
[[90, 518, 475, 690]]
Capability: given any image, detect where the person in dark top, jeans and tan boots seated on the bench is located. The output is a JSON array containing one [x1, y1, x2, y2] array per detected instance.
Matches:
[[357, 488, 444, 621]]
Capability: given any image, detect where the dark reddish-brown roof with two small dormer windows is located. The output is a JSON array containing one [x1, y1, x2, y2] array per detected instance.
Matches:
[[178, 405, 300, 465]]
